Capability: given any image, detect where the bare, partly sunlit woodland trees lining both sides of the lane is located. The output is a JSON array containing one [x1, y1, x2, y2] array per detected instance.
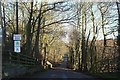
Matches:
[[0, 0, 120, 77]]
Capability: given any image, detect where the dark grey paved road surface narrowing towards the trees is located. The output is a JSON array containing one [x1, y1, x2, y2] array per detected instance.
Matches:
[[23, 67, 101, 80]]
